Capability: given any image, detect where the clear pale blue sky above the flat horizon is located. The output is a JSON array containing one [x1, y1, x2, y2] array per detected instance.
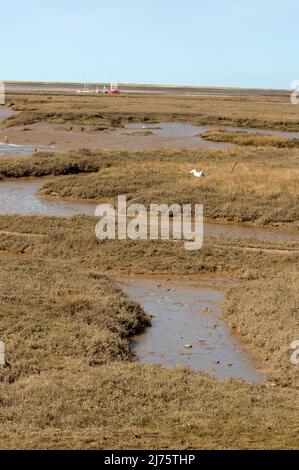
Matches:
[[0, 0, 299, 88]]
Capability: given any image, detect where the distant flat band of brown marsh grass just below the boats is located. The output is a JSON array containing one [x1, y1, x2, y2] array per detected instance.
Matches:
[[4, 94, 299, 131]]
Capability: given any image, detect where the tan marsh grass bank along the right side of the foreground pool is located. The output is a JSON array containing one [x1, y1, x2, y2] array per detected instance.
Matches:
[[223, 274, 299, 387]]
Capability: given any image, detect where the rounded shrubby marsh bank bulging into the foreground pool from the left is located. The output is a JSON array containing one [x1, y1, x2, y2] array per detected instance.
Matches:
[[0, 256, 147, 383]]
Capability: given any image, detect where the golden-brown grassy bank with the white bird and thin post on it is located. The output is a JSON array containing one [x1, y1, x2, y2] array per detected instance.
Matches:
[[34, 149, 299, 225]]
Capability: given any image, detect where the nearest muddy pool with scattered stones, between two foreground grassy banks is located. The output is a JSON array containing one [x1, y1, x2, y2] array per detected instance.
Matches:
[[118, 277, 264, 382]]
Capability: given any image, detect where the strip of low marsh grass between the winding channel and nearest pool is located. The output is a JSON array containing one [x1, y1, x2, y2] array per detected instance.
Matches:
[[0, 216, 299, 279]]
